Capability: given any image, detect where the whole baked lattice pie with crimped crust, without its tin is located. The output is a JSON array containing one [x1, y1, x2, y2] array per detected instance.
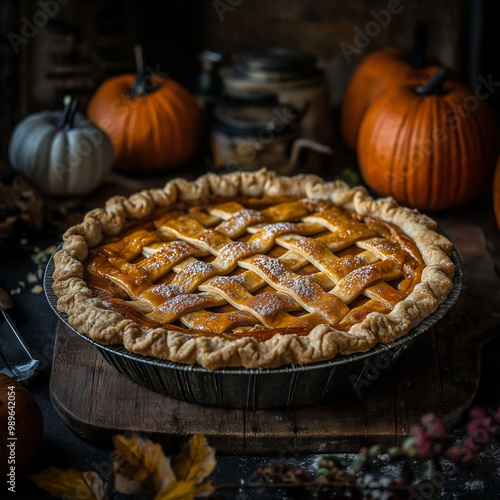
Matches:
[[54, 170, 454, 369]]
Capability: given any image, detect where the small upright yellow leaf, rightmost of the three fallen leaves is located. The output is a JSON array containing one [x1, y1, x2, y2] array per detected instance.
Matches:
[[173, 434, 217, 484]]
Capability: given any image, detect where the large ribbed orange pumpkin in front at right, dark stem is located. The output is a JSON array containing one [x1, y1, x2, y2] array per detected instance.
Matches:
[[357, 68, 499, 210]]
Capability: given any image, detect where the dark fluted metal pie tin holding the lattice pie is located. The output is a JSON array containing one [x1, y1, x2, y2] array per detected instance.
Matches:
[[43, 246, 463, 410]]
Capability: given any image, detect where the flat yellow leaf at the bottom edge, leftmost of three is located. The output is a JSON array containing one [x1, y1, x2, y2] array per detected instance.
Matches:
[[28, 467, 109, 500]]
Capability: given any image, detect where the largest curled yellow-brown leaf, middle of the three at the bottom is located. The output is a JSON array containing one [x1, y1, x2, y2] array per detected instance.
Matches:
[[113, 434, 176, 496]]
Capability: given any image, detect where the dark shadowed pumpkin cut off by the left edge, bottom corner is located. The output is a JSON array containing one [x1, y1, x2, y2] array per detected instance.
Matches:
[[0, 373, 43, 476]]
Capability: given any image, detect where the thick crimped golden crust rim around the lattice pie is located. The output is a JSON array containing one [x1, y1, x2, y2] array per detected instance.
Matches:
[[53, 169, 455, 370]]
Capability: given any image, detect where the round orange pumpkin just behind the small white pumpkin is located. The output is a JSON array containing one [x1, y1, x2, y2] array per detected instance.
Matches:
[[87, 47, 204, 172]]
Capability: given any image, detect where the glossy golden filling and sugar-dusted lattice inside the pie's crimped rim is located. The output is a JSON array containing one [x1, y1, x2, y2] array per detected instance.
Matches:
[[85, 197, 424, 339]]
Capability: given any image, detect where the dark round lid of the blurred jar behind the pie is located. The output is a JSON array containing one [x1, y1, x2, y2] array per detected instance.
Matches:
[[234, 47, 316, 81]]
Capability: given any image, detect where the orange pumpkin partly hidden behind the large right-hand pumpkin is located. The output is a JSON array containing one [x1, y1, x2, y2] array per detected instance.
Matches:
[[340, 24, 439, 149]]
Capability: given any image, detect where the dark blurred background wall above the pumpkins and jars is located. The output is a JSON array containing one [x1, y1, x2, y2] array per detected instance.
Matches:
[[0, 0, 500, 159]]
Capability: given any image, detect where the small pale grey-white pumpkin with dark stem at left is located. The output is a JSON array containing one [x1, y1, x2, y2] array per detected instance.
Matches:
[[9, 97, 113, 196]]
